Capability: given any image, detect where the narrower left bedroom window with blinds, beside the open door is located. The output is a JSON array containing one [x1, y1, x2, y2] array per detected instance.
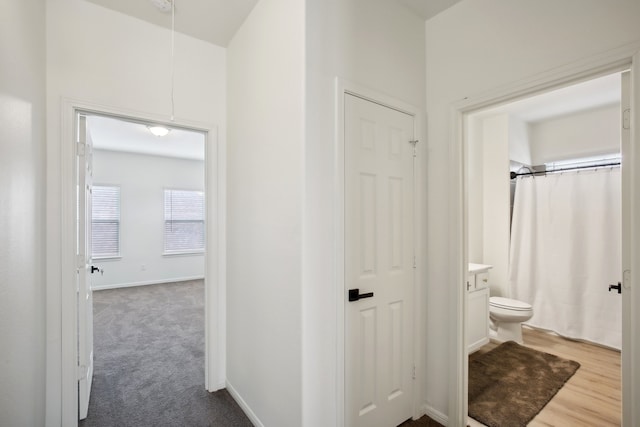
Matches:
[[91, 185, 120, 258]]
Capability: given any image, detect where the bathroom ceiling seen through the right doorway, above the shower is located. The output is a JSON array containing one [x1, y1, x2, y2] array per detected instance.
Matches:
[[474, 73, 621, 123]]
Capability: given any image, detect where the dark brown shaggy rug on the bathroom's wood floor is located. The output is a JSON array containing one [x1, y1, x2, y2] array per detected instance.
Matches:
[[469, 341, 580, 427]]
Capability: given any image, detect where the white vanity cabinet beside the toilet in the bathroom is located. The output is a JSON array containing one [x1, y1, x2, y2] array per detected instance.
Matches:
[[467, 264, 492, 353]]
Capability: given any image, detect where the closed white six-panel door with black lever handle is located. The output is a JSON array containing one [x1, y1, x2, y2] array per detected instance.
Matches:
[[344, 95, 415, 427]]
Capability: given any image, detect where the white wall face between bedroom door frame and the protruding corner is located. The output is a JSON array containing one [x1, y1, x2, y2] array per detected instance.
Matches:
[[227, 0, 305, 427]]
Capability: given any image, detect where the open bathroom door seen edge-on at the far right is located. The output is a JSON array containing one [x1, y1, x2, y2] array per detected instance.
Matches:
[[620, 71, 633, 427]]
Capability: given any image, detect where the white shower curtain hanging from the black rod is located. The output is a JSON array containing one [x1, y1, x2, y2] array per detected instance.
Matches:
[[509, 168, 622, 349]]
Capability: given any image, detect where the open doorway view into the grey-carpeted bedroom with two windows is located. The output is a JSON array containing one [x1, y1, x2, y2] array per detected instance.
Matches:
[[78, 114, 206, 422]]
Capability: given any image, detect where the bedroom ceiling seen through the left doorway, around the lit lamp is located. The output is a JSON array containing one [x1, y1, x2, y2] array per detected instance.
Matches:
[[87, 116, 205, 160]]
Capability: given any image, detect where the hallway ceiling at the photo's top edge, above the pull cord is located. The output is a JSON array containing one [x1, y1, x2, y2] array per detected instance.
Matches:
[[86, 0, 460, 47]]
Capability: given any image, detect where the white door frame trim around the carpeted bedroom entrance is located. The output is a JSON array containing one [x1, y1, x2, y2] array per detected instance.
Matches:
[[52, 100, 226, 425]]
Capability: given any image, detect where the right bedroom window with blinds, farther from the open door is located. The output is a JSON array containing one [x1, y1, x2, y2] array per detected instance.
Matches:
[[164, 190, 204, 254]]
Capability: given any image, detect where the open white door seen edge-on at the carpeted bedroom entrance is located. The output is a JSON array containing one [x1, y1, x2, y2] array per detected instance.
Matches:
[[76, 115, 96, 420]]
